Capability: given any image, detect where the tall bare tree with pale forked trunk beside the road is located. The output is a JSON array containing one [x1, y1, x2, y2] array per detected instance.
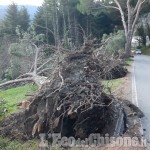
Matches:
[[99, 0, 146, 57]]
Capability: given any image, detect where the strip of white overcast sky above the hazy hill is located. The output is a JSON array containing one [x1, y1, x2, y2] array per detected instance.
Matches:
[[0, 0, 44, 6]]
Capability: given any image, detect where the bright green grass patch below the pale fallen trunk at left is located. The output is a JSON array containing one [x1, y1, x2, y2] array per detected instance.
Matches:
[[0, 84, 37, 115]]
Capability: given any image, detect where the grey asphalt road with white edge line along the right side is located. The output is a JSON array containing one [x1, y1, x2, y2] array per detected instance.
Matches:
[[132, 55, 150, 150]]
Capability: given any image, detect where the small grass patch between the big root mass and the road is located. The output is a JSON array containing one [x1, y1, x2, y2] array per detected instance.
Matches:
[[102, 78, 124, 94]]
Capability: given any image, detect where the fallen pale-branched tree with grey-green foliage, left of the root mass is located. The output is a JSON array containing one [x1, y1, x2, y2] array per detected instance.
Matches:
[[0, 27, 59, 88]]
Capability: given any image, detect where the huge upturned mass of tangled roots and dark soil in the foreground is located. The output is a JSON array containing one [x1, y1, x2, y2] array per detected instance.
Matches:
[[0, 45, 136, 140]]
